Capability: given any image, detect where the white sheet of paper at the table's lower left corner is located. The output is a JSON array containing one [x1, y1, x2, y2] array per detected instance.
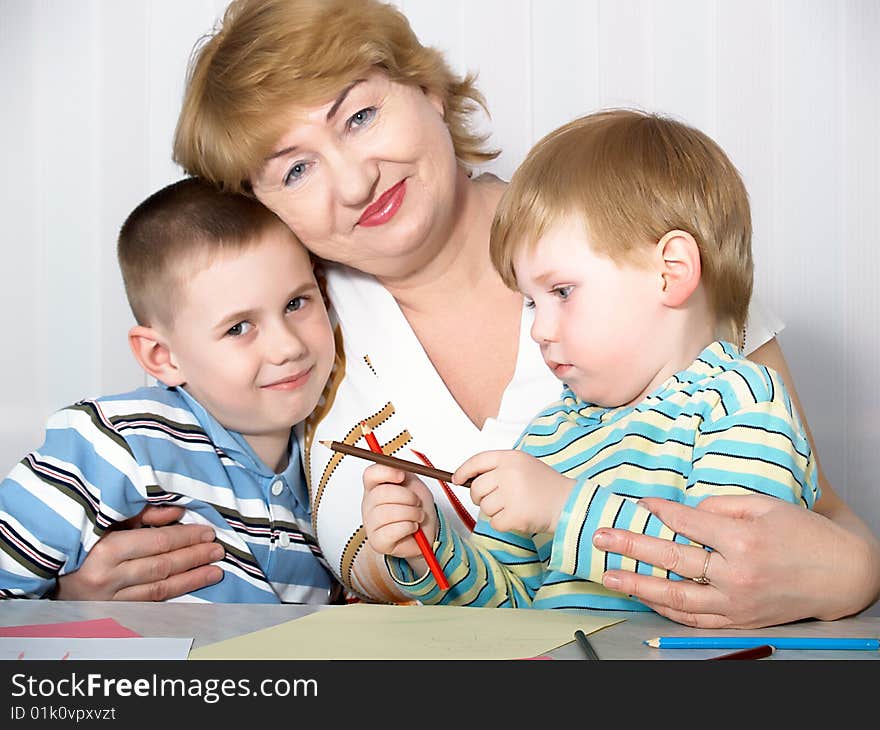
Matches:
[[0, 636, 193, 659]]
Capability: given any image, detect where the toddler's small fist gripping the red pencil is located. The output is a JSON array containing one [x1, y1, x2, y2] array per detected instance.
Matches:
[[361, 464, 437, 560]]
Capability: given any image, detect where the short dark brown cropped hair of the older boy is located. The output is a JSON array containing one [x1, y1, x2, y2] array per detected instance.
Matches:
[[116, 177, 297, 327]]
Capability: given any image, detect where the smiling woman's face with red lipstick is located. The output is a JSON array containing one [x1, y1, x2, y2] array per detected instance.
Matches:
[[252, 71, 457, 277]]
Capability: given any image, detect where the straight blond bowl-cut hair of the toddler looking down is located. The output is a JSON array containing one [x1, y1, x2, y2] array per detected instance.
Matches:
[[490, 109, 753, 332]]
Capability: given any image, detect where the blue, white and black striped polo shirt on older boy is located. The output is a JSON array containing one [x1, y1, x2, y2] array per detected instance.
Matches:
[[0, 386, 338, 603]]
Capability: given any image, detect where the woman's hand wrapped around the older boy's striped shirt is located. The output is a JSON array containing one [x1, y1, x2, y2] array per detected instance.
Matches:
[[53, 506, 224, 601]]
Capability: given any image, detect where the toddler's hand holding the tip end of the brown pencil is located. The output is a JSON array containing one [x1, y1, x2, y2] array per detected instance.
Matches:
[[452, 451, 574, 533]]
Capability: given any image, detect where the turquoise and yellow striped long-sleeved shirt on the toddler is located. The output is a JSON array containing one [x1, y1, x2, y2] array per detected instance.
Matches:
[[386, 342, 819, 610]]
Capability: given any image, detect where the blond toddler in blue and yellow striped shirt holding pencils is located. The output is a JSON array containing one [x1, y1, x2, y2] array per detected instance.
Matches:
[[363, 110, 818, 610]]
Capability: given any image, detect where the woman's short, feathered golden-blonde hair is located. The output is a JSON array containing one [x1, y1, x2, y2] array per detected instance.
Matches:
[[174, 0, 498, 191]]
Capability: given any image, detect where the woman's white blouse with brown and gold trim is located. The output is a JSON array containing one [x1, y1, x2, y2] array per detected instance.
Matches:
[[298, 258, 783, 601]]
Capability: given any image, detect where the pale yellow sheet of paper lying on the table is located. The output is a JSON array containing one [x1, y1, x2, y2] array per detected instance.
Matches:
[[189, 604, 623, 659]]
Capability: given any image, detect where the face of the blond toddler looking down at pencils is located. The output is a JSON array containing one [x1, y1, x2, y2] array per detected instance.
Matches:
[[514, 219, 662, 407]]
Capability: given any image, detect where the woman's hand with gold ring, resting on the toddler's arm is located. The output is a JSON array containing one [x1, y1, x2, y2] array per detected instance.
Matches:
[[593, 495, 880, 629]]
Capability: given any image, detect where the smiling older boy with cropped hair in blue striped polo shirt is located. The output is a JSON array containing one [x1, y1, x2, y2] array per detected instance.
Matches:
[[0, 178, 337, 603]]
